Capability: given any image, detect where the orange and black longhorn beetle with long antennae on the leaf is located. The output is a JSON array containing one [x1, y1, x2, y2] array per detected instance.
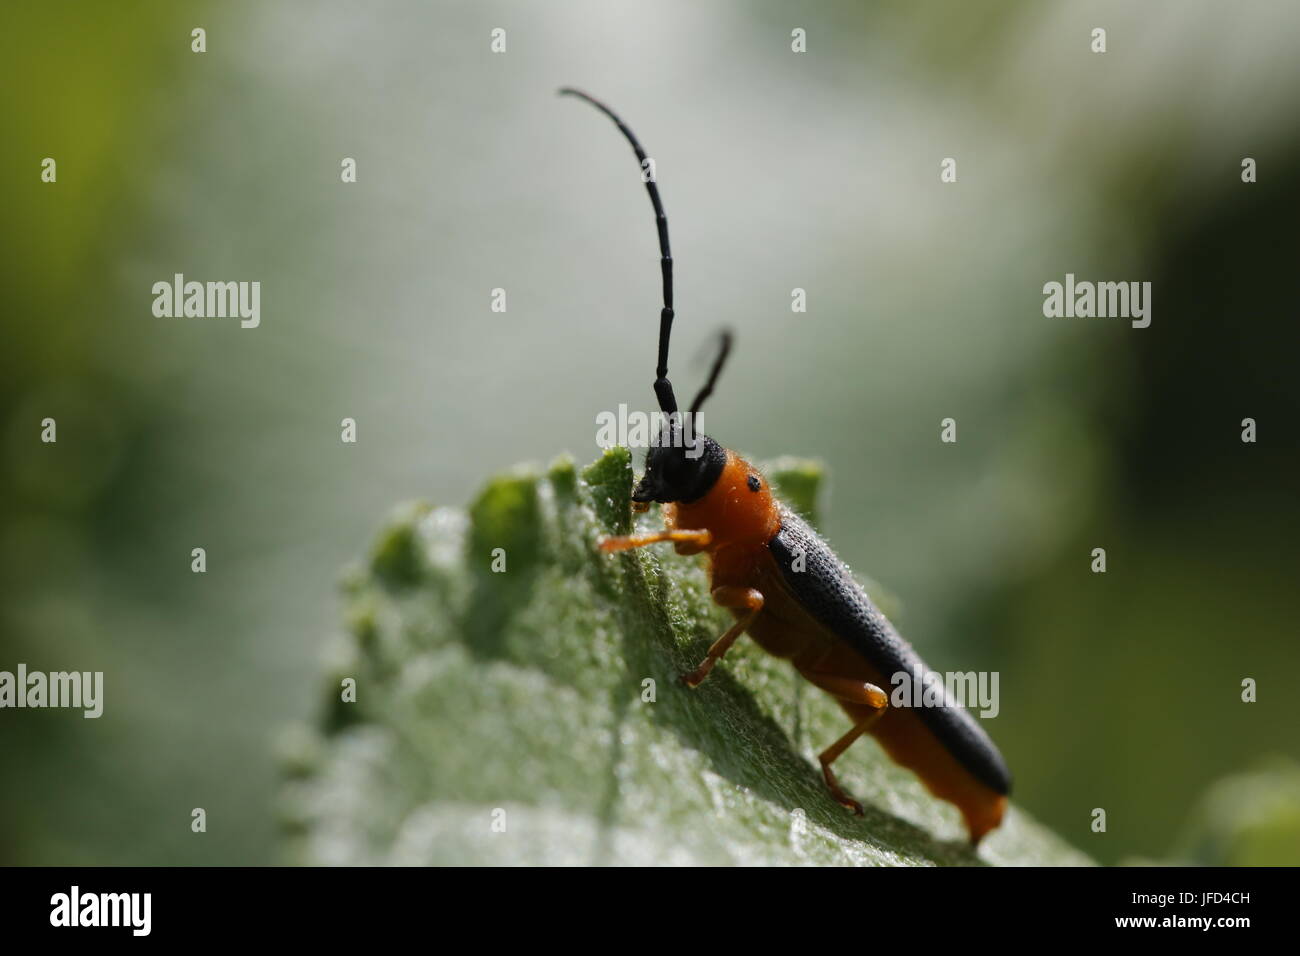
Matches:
[[560, 87, 1011, 845]]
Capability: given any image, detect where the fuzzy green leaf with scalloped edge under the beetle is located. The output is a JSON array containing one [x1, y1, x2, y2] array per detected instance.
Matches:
[[282, 449, 1089, 865]]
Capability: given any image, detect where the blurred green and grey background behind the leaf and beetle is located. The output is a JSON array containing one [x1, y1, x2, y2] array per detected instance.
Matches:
[[0, 0, 1300, 864]]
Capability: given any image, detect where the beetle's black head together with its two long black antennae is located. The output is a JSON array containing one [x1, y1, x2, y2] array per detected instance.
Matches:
[[560, 87, 732, 503]]
